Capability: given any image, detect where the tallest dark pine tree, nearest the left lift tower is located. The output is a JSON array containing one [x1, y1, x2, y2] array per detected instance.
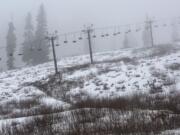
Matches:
[[32, 4, 49, 65]]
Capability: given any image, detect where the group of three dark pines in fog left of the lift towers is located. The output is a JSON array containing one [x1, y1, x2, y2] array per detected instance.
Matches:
[[6, 4, 49, 70]]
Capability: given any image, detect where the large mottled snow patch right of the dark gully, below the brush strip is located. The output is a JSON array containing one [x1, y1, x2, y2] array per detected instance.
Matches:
[[66, 47, 180, 98]]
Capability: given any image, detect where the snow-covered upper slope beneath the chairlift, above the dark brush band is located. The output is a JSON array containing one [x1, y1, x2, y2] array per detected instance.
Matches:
[[0, 45, 180, 134]]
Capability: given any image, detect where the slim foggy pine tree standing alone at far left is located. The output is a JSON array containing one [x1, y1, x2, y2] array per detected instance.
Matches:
[[6, 22, 16, 70]]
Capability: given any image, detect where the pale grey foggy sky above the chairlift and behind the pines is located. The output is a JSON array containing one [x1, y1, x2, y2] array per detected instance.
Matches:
[[0, 0, 180, 70]]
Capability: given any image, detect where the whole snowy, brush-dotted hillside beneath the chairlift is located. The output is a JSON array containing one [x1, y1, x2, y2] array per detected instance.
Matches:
[[0, 44, 180, 134]]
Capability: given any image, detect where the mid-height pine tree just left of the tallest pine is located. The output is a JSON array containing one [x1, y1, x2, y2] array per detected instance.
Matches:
[[22, 13, 34, 65]]
